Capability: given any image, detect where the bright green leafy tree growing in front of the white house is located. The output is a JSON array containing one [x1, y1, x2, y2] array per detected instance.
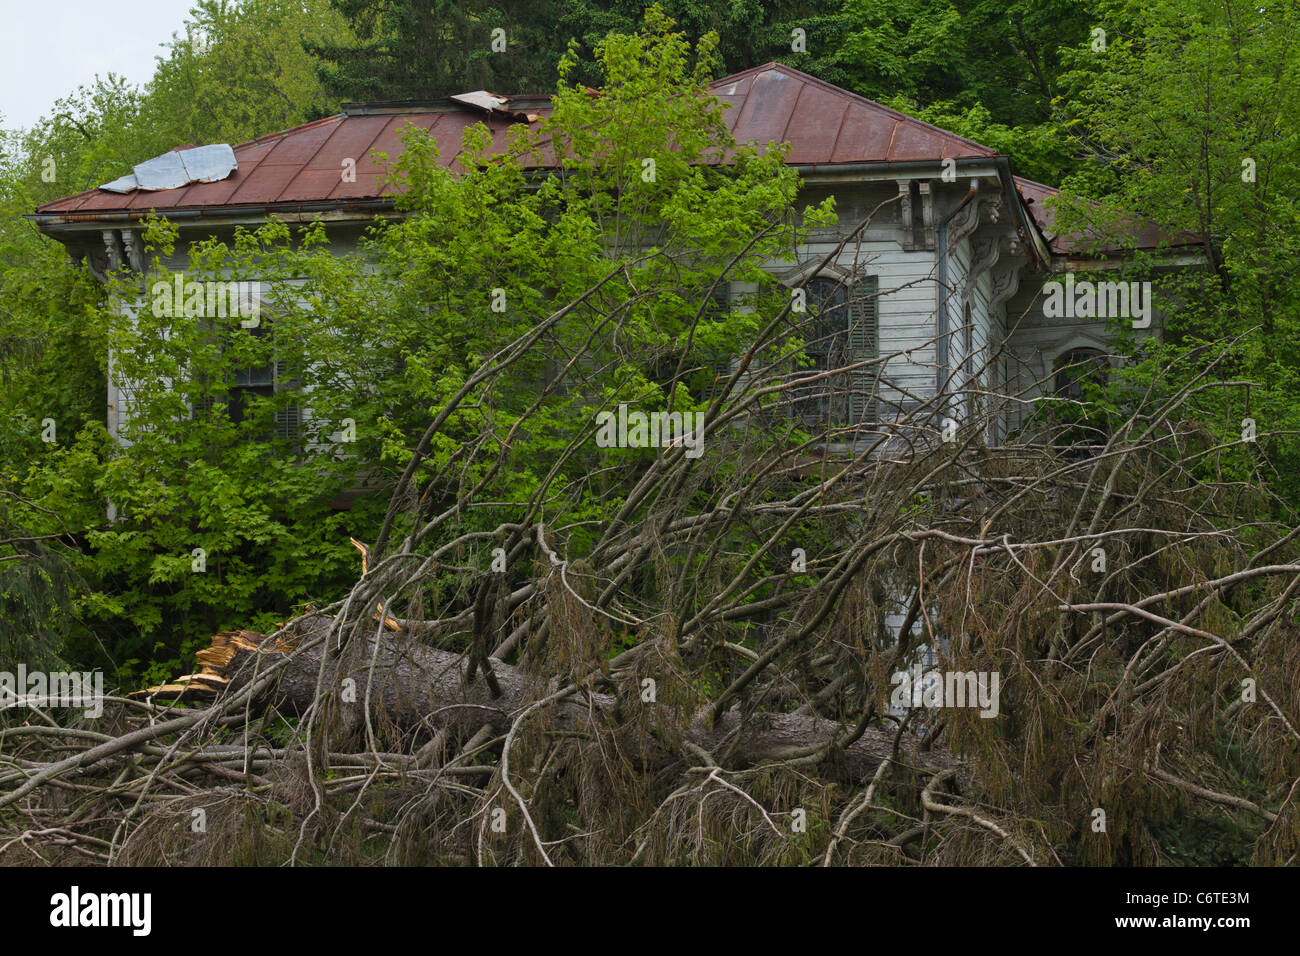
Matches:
[[5, 10, 831, 676]]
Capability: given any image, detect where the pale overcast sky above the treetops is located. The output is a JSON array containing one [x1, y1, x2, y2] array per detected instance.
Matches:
[[0, 0, 194, 129]]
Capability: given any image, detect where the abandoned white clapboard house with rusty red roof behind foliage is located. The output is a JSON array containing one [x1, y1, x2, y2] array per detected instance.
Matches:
[[31, 62, 1196, 455]]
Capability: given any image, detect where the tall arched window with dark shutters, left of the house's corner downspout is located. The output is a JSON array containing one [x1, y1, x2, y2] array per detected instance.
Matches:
[[796, 276, 879, 429]]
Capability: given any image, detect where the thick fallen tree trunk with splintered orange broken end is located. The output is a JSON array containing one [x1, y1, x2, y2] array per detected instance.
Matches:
[[139, 615, 957, 783]]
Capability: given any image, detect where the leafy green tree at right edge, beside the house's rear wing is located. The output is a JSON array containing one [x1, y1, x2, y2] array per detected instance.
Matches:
[[1061, 0, 1300, 503]]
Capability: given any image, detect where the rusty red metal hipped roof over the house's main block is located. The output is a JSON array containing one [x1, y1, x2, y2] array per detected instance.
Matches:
[[36, 62, 997, 215]]
